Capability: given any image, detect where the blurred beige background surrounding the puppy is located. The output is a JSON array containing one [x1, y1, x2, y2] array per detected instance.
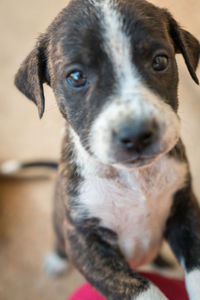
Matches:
[[0, 0, 200, 300]]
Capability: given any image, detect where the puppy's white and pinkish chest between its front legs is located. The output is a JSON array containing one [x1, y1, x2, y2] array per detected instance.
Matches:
[[79, 157, 186, 267]]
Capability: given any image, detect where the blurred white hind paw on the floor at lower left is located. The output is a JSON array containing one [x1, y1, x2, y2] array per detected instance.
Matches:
[[44, 252, 68, 277]]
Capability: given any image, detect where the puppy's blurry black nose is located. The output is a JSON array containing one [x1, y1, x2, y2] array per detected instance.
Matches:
[[114, 121, 158, 153]]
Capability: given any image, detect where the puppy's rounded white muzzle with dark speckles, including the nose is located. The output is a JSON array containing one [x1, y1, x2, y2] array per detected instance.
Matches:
[[90, 96, 180, 167]]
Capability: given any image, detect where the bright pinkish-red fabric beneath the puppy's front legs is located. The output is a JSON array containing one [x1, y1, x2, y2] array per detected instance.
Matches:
[[68, 273, 189, 300]]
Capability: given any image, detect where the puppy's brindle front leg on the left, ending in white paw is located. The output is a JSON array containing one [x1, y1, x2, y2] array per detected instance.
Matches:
[[65, 220, 167, 300]]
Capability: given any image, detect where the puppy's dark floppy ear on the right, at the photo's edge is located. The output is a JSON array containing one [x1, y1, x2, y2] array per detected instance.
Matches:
[[165, 11, 200, 84]]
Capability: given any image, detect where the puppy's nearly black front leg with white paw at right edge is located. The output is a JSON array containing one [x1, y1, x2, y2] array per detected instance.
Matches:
[[165, 184, 200, 300]]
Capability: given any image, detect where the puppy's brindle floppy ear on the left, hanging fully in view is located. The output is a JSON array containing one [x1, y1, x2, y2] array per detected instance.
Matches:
[[15, 36, 49, 118]]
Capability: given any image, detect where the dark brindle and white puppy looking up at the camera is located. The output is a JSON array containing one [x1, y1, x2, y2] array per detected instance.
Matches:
[[15, 0, 200, 300]]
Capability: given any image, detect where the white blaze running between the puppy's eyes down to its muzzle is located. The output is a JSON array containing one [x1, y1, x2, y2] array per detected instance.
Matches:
[[91, 0, 148, 117]]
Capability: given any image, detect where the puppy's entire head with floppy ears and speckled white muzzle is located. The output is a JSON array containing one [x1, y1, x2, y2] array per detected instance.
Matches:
[[16, 0, 200, 167]]
